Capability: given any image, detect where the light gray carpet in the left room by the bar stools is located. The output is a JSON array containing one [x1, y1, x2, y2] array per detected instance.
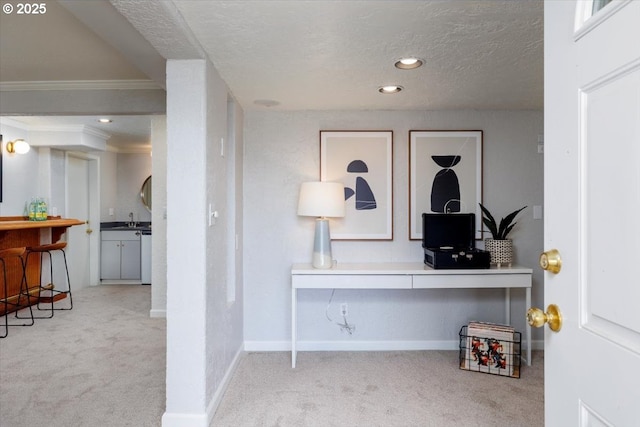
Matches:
[[0, 285, 166, 427]]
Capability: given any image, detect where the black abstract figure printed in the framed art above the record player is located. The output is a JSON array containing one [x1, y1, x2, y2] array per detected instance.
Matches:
[[431, 156, 462, 213]]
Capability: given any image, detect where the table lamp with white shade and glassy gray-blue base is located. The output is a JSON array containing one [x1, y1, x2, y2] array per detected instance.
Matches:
[[298, 182, 345, 268]]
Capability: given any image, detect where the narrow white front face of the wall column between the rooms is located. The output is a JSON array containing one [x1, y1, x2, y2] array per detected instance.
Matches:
[[162, 60, 207, 427]]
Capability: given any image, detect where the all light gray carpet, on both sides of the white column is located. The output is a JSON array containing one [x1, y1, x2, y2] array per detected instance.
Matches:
[[0, 285, 544, 427]]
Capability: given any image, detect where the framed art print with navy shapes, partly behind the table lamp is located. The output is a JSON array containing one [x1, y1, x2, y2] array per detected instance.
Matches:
[[320, 131, 393, 240]]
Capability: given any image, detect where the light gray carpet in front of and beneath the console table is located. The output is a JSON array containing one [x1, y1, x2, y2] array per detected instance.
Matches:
[[212, 351, 544, 427]]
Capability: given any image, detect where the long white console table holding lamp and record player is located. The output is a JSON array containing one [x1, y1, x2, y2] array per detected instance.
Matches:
[[291, 262, 533, 368]]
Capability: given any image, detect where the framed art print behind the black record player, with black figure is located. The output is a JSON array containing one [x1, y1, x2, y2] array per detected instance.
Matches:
[[409, 130, 482, 240]]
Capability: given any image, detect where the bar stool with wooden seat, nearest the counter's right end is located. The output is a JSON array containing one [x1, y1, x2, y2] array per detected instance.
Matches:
[[25, 242, 73, 319]]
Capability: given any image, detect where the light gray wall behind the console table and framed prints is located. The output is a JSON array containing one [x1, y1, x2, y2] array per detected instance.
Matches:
[[244, 110, 543, 350]]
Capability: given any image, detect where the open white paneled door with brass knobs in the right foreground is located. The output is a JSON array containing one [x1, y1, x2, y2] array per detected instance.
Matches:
[[545, 0, 640, 427]]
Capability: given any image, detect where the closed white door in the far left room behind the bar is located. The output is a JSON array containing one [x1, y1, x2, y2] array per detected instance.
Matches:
[[67, 154, 100, 288]]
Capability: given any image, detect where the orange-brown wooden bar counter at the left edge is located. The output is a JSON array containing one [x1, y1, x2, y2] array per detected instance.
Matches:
[[0, 216, 84, 314]]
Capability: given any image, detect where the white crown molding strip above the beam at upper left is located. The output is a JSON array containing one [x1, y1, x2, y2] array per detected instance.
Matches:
[[0, 80, 164, 92]]
